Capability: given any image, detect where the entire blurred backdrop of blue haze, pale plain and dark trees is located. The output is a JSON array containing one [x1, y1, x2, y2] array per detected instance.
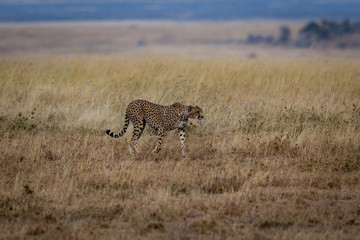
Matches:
[[0, 0, 360, 58]]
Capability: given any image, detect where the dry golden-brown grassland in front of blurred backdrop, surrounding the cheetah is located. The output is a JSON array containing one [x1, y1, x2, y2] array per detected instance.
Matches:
[[0, 56, 360, 239]]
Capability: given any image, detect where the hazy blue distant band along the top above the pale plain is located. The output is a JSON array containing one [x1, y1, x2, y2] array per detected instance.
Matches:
[[0, 0, 360, 22]]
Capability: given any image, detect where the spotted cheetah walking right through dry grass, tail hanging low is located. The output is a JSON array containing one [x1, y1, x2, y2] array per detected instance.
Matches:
[[105, 100, 204, 157]]
